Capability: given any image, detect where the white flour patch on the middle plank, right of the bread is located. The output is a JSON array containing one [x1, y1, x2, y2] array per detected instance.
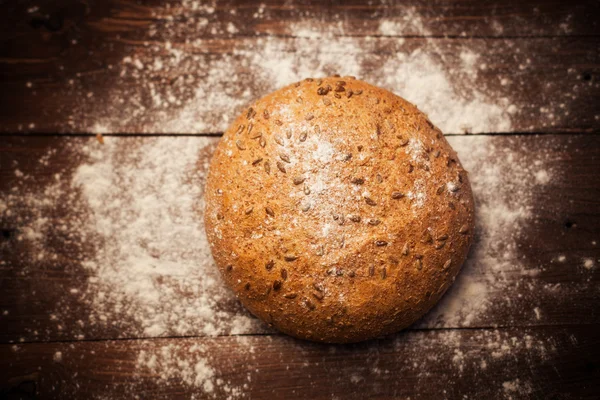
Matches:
[[421, 136, 559, 326]]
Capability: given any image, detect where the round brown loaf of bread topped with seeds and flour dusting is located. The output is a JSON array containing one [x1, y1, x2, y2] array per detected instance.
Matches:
[[204, 76, 474, 343]]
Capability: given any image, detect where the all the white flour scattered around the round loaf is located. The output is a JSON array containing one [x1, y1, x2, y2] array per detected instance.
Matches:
[[0, 0, 595, 398]]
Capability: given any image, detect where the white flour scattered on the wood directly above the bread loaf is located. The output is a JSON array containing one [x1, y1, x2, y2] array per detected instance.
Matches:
[[58, 0, 528, 133]]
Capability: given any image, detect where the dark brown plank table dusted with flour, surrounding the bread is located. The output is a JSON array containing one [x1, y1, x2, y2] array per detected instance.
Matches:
[[0, 0, 600, 399]]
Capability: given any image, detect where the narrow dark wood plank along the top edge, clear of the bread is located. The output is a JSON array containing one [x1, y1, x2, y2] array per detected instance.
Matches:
[[0, 0, 600, 37]]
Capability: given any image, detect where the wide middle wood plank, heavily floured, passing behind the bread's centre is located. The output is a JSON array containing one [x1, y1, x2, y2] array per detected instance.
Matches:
[[0, 135, 600, 342]]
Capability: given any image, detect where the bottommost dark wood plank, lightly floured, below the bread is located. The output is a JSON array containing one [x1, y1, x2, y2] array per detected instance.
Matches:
[[0, 325, 600, 399]]
